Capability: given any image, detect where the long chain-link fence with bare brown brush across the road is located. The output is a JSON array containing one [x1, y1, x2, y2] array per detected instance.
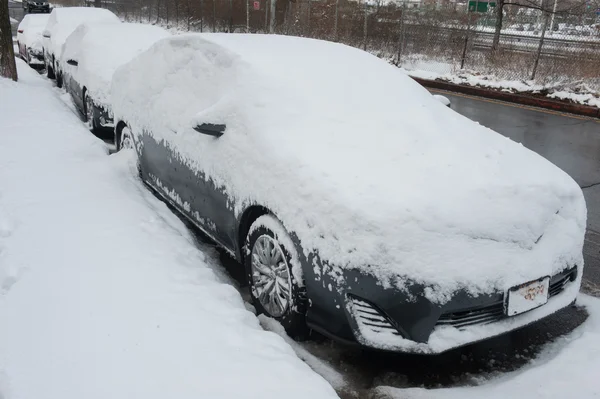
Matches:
[[50, 0, 600, 90]]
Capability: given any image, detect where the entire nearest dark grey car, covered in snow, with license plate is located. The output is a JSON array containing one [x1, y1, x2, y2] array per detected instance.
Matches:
[[111, 34, 586, 353]]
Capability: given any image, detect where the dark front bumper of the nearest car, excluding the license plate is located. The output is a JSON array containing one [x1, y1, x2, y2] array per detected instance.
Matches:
[[306, 267, 582, 354]]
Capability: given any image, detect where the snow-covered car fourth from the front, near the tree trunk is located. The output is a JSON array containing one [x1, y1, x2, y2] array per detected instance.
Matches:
[[17, 14, 48, 68]]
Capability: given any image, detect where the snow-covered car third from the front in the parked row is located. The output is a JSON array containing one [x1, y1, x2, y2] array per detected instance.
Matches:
[[42, 7, 121, 87]]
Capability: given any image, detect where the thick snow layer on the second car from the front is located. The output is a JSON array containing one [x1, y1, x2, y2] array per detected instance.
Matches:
[[62, 23, 170, 108]]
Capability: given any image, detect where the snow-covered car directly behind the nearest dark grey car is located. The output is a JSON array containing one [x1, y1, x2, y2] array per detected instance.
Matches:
[[60, 22, 170, 133]]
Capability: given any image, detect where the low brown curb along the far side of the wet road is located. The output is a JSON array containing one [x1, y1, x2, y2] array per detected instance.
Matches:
[[412, 77, 600, 118]]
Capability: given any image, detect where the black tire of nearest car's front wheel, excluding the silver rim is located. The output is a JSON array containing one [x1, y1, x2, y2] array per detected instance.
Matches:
[[244, 215, 310, 340]]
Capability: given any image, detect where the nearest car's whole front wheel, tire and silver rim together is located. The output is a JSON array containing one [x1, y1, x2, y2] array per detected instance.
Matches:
[[244, 215, 309, 339]]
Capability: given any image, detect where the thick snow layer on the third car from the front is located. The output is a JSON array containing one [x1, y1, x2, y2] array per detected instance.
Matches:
[[44, 7, 121, 60]]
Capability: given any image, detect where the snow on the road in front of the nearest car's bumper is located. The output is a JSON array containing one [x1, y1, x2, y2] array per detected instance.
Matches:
[[374, 295, 600, 399]]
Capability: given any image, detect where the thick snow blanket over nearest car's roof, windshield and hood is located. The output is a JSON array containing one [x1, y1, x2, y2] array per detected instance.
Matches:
[[112, 34, 586, 303]]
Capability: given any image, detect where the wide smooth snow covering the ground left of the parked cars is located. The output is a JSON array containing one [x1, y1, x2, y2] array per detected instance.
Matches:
[[0, 62, 336, 399]]
